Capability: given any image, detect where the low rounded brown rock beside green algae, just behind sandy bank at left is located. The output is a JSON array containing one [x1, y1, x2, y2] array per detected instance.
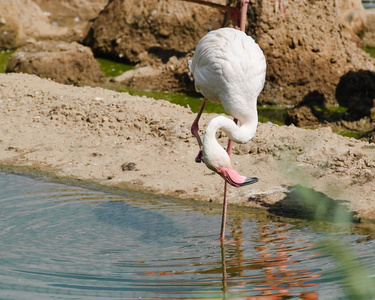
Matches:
[[6, 41, 105, 86]]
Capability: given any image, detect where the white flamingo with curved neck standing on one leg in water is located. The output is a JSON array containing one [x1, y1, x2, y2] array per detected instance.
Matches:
[[189, 28, 266, 241]]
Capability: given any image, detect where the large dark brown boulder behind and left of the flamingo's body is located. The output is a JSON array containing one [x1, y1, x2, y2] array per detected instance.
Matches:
[[84, 0, 226, 64]]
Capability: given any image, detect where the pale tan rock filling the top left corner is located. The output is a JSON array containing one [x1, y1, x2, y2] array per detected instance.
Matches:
[[0, 0, 108, 49]]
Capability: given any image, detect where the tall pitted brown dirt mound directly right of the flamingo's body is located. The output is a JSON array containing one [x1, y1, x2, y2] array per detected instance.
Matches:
[[248, 0, 375, 105]]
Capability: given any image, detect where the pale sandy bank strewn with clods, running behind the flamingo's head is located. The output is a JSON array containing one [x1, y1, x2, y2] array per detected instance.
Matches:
[[0, 74, 375, 219]]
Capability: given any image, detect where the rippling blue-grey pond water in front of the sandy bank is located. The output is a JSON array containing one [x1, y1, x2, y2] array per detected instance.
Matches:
[[0, 173, 375, 299]]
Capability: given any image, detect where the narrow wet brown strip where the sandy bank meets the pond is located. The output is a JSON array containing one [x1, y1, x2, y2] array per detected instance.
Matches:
[[0, 164, 375, 244]]
